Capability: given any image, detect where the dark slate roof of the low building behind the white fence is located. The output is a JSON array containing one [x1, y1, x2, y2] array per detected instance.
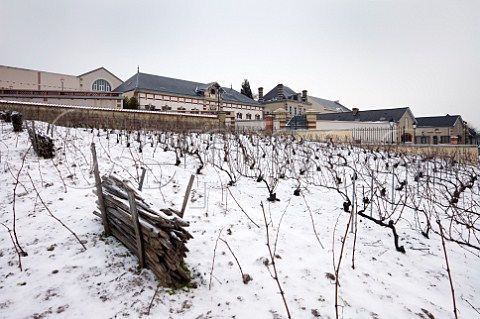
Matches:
[[317, 107, 413, 122]]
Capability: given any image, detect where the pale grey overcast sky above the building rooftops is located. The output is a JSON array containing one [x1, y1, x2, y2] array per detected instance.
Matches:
[[0, 0, 480, 129]]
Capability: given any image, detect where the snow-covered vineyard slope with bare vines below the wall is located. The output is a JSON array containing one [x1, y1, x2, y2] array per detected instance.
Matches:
[[0, 122, 480, 319]]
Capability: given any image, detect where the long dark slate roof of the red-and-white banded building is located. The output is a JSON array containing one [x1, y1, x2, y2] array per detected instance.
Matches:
[[113, 73, 259, 104]]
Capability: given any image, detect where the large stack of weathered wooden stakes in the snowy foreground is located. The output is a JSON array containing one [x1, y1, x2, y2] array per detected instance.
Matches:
[[92, 143, 193, 287]]
